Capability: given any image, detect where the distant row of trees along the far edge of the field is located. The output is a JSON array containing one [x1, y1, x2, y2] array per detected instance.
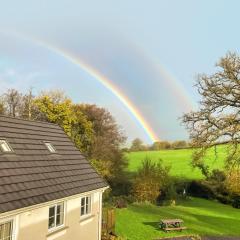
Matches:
[[126, 138, 190, 152]]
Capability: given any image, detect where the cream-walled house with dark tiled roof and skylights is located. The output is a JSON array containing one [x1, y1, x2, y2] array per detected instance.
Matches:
[[0, 116, 107, 240]]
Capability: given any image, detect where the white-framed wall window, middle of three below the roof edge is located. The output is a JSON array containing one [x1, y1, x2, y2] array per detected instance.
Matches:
[[48, 202, 64, 229]]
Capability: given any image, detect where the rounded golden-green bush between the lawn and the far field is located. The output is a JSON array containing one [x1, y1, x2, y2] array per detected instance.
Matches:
[[133, 158, 170, 203]]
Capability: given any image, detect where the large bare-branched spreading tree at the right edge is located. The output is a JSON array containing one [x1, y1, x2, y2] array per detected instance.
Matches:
[[183, 53, 240, 168]]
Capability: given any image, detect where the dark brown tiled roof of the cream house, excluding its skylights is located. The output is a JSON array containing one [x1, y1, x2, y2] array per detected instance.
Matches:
[[0, 115, 107, 213]]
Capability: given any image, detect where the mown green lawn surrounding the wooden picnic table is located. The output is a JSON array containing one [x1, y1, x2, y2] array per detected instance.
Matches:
[[116, 198, 240, 240]]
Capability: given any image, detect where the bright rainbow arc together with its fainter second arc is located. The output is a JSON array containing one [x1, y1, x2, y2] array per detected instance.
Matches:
[[1, 31, 194, 142]]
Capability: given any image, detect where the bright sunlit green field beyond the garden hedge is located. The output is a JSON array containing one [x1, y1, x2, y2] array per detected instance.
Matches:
[[127, 145, 226, 179]]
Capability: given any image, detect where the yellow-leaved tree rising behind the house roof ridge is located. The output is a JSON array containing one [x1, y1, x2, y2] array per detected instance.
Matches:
[[34, 91, 93, 154]]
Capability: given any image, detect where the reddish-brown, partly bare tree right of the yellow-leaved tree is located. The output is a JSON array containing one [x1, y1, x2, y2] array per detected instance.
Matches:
[[79, 104, 127, 183]]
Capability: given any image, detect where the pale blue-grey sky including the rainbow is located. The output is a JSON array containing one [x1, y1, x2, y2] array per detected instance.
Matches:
[[0, 0, 240, 144]]
